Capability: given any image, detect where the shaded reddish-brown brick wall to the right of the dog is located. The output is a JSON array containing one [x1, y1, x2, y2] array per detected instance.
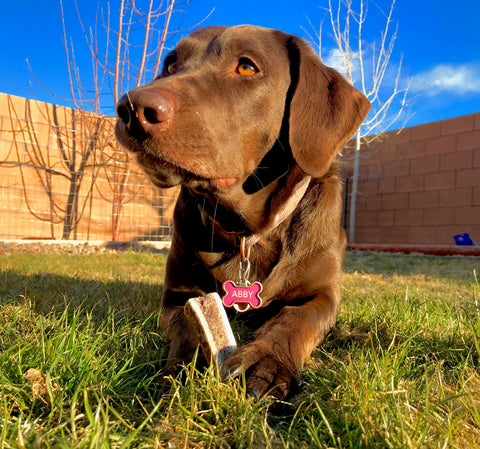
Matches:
[[346, 113, 480, 245]]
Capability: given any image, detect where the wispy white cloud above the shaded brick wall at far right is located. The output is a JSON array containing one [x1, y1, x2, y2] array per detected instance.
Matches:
[[410, 63, 480, 96]]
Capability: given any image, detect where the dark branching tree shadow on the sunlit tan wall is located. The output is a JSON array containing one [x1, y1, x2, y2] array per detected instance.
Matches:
[[0, 97, 108, 240]]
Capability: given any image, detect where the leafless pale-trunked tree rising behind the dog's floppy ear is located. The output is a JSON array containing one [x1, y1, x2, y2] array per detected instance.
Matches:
[[316, 0, 410, 242]]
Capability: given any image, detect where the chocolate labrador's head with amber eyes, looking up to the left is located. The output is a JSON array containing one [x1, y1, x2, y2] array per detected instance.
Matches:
[[117, 25, 370, 194]]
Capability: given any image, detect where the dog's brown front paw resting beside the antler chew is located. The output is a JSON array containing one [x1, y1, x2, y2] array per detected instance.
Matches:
[[221, 342, 298, 399]]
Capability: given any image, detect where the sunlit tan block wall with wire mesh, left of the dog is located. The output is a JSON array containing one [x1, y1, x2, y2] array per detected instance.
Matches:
[[0, 94, 178, 241]]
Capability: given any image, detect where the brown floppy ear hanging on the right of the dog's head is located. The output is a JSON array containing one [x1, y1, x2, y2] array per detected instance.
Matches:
[[289, 36, 370, 177]]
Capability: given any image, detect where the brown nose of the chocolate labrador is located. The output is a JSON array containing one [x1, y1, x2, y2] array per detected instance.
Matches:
[[117, 88, 173, 139]]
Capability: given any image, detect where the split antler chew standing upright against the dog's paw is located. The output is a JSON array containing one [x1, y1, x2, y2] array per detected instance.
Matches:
[[185, 293, 237, 366]]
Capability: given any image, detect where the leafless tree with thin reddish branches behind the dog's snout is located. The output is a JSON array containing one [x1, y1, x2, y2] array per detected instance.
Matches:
[[61, 0, 198, 240]]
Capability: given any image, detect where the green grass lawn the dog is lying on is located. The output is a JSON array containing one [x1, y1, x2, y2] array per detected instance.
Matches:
[[0, 252, 480, 449]]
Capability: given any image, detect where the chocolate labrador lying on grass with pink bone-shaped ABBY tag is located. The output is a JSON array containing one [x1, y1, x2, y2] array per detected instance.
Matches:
[[117, 25, 370, 398]]
